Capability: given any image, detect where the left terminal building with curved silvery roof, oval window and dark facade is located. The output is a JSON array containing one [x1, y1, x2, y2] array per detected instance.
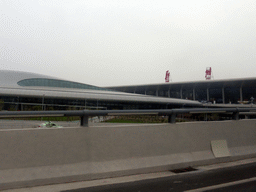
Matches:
[[0, 70, 202, 111]]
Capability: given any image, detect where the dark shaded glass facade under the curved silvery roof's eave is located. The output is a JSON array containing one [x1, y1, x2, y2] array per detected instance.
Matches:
[[0, 96, 170, 111]]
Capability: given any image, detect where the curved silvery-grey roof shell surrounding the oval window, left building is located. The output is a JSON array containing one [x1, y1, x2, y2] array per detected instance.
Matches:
[[0, 70, 201, 106]]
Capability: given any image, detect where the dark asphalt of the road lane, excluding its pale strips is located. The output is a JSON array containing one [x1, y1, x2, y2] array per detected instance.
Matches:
[[62, 163, 256, 192]]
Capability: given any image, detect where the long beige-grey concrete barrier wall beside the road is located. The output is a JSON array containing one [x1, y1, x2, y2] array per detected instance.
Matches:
[[0, 120, 256, 189]]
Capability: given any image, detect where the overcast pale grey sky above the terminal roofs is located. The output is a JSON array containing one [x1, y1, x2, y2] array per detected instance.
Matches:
[[0, 0, 256, 86]]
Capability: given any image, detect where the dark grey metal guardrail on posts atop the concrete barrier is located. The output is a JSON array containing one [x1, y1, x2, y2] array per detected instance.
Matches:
[[0, 108, 256, 127]]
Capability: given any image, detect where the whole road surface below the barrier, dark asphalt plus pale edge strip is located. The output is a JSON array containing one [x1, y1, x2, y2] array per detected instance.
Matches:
[[5, 158, 256, 192]]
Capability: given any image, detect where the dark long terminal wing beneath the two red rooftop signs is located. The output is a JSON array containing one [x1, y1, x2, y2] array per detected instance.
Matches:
[[108, 78, 256, 104]]
